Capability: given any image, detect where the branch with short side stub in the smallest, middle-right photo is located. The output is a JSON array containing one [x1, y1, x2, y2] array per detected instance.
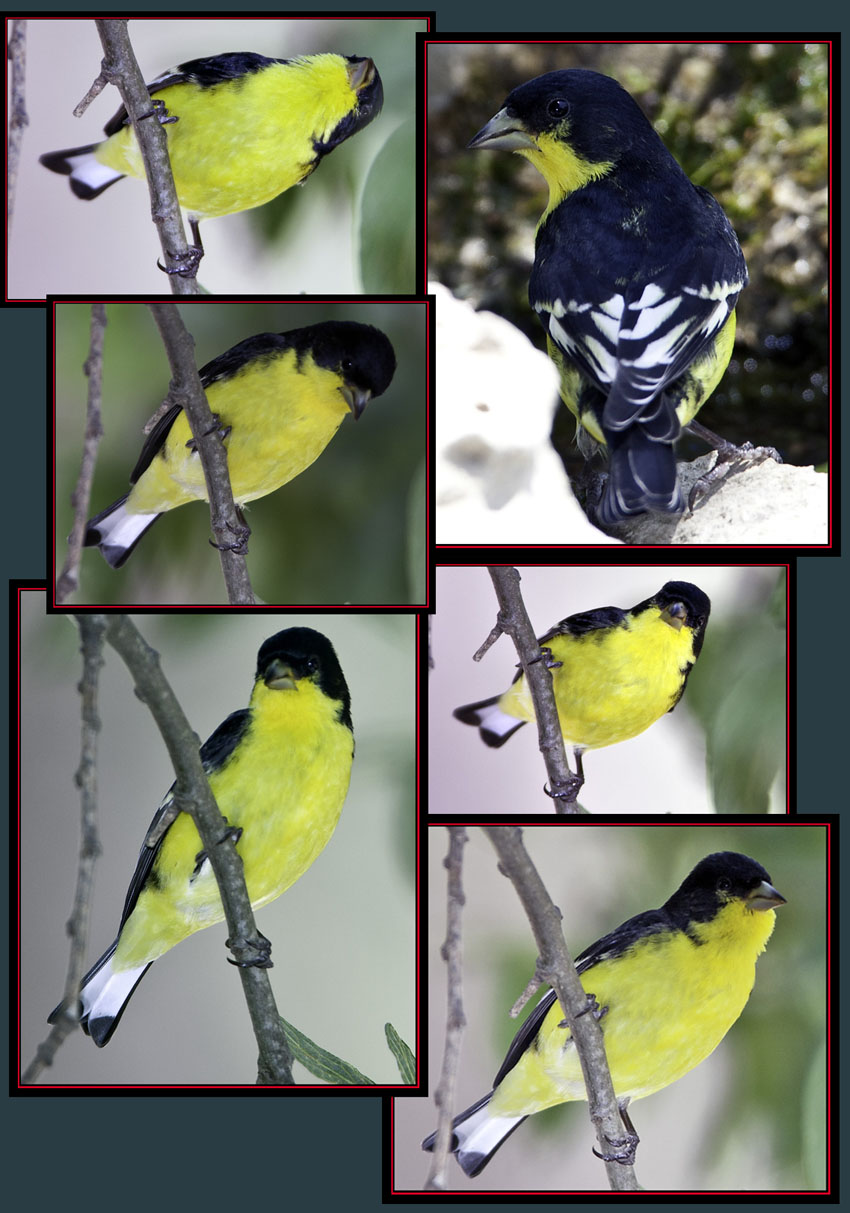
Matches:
[[474, 565, 583, 814]]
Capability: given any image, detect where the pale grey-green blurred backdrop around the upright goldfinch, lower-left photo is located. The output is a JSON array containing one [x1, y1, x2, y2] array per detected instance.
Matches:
[[21, 592, 416, 1087]]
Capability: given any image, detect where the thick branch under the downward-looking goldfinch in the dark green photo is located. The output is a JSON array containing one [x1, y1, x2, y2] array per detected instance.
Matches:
[[148, 303, 256, 607]]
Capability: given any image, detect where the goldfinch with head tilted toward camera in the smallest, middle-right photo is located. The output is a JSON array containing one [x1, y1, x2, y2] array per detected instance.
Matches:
[[453, 581, 711, 774]]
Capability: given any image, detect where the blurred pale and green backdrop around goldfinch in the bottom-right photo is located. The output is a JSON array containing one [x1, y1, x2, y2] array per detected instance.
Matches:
[[404, 819, 827, 1191]]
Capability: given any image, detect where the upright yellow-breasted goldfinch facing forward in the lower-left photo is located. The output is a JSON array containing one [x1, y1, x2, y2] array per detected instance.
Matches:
[[49, 627, 354, 1046]]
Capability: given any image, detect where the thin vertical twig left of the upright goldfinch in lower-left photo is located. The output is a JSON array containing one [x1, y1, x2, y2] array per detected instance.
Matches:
[[22, 615, 105, 1084]]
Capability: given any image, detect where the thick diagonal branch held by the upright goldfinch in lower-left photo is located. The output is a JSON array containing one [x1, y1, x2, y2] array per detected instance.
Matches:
[[105, 615, 293, 1086]]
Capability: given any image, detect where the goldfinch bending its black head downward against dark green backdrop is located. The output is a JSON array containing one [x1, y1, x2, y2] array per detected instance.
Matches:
[[85, 320, 395, 569]]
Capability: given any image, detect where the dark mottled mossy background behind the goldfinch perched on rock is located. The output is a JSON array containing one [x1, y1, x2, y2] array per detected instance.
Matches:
[[428, 42, 829, 474]]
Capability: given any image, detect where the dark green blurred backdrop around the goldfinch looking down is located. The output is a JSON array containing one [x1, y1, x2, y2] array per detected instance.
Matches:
[[56, 300, 427, 604]]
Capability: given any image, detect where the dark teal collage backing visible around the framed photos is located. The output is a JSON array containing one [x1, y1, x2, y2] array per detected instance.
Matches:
[[0, 9, 850, 1213]]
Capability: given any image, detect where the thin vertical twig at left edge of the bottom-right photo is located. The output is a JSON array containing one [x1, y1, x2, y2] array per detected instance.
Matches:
[[424, 826, 467, 1191]]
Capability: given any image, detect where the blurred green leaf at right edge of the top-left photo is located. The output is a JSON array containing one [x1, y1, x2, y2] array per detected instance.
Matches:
[[360, 120, 416, 295]]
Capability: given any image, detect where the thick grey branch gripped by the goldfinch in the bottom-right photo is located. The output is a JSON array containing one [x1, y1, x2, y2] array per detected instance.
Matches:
[[483, 826, 639, 1192]]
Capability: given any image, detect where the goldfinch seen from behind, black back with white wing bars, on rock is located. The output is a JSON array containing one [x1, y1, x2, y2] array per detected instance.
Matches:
[[469, 70, 751, 524]]
